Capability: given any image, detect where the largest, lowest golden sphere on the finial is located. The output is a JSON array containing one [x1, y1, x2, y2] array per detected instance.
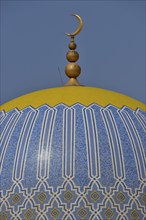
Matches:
[[65, 63, 81, 78]]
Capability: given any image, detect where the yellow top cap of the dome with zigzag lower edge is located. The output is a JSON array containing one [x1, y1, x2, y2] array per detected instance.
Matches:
[[1, 86, 146, 112]]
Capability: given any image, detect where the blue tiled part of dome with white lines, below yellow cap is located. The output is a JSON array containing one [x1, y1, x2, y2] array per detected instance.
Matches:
[[0, 104, 146, 220]]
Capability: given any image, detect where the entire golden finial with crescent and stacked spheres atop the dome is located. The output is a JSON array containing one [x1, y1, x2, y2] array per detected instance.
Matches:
[[65, 14, 83, 86]]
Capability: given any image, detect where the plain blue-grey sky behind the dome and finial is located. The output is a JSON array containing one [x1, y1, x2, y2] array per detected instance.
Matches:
[[0, 0, 146, 104]]
